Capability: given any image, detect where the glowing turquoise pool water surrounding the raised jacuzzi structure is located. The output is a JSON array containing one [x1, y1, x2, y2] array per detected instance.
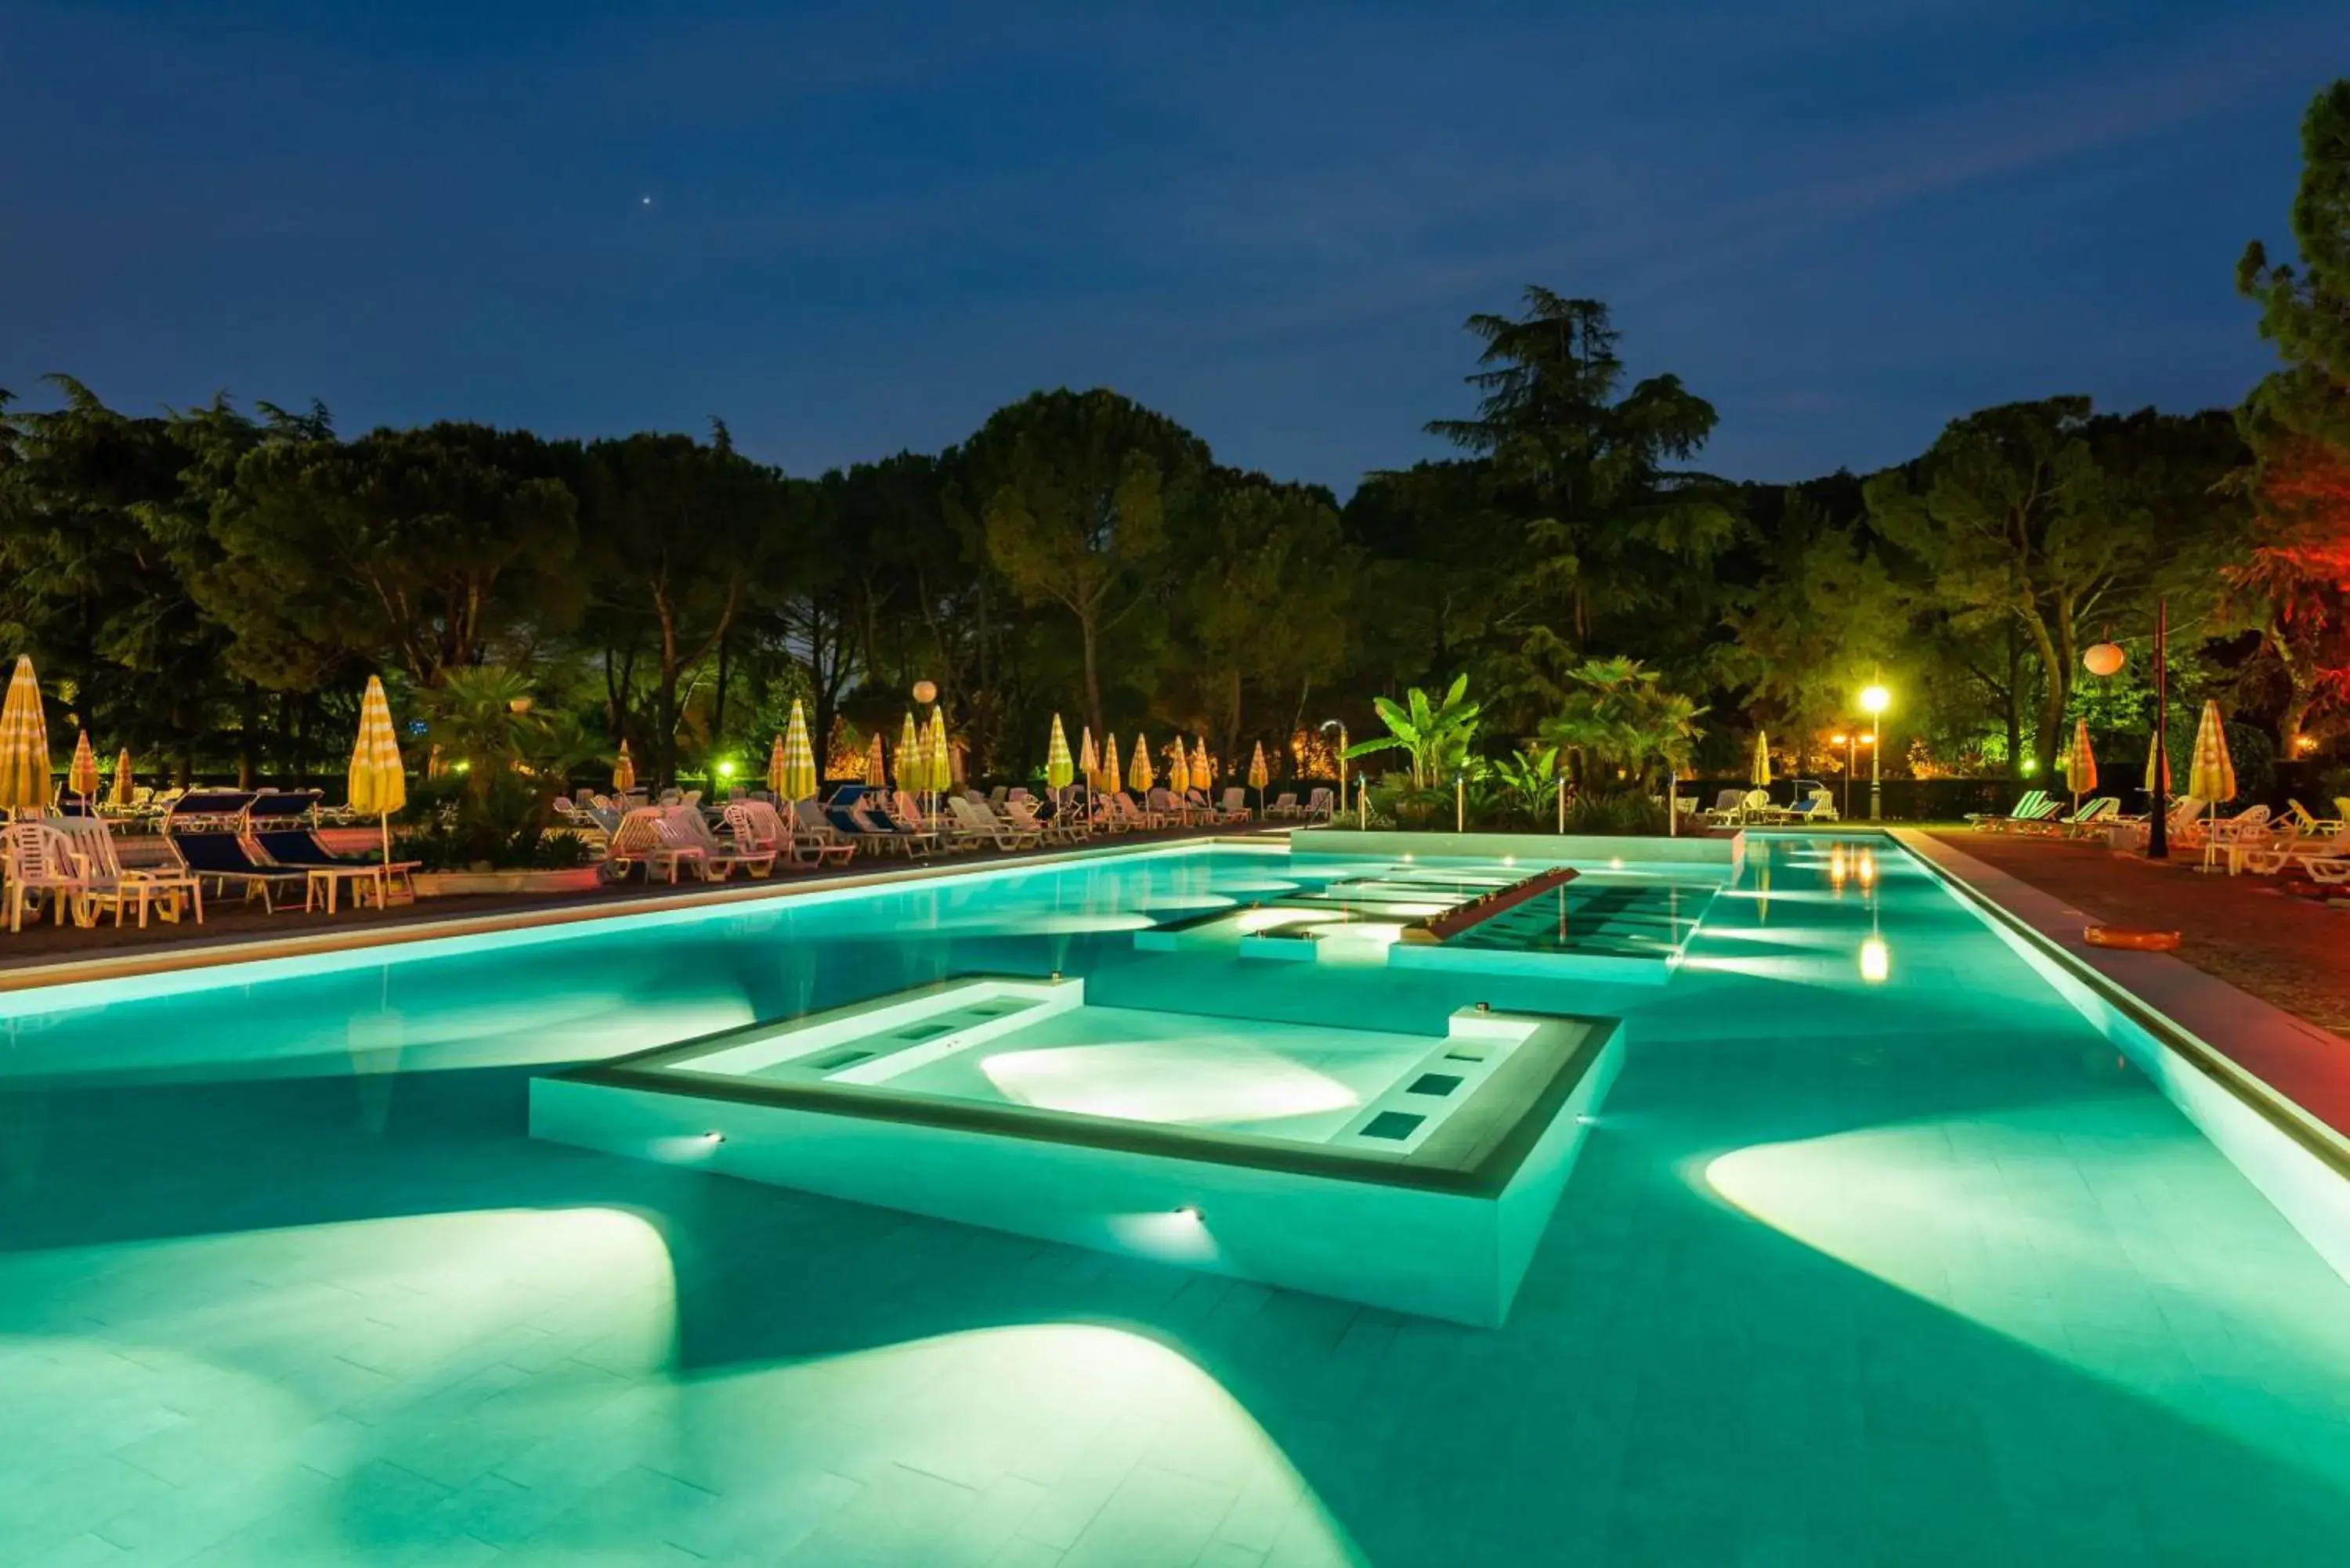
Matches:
[[0, 837, 2350, 1568]]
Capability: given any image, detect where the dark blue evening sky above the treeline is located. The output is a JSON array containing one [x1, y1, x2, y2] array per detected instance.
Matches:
[[0, 0, 2350, 491]]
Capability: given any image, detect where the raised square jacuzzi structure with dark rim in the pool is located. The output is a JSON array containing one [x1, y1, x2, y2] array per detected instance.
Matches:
[[531, 976, 1619, 1326]]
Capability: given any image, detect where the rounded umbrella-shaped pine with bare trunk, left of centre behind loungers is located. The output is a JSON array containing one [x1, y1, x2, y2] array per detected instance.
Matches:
[[968, 390, 1210, 731]]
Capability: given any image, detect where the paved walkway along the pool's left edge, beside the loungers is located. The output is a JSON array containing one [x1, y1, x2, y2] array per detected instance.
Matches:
[[0, 823, 1292, 976]]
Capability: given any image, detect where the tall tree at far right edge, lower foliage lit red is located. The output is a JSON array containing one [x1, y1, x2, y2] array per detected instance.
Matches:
[[2235, 80, 2350, 754]]
